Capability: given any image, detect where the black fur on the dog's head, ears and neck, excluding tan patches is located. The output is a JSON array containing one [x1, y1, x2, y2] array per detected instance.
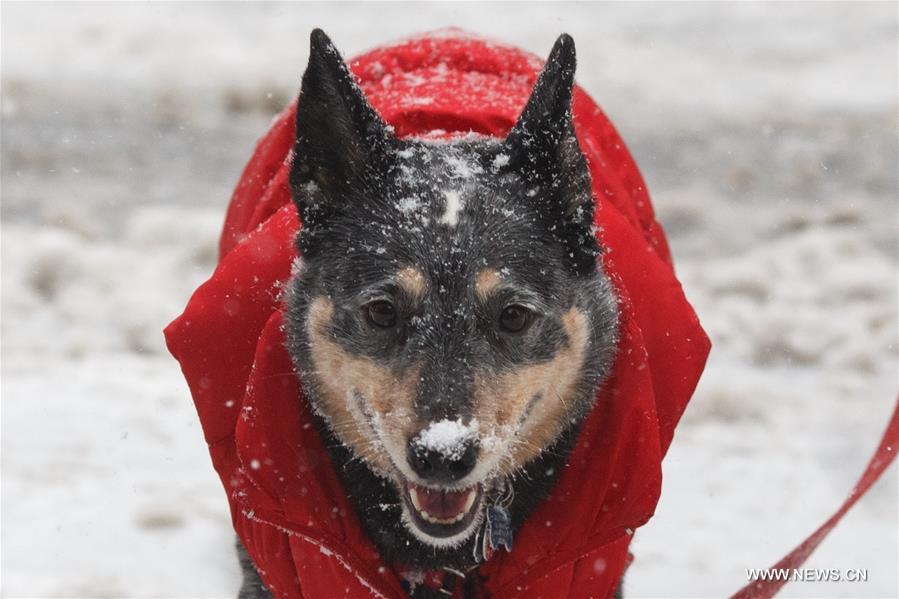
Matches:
[[244, 30, 618, 596]]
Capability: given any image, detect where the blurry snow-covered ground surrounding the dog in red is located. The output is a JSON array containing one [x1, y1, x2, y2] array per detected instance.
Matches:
[[0, 3, 899, 597]]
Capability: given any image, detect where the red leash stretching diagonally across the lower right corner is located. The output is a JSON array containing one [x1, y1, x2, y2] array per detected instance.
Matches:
[[731, 400, 899, 599]]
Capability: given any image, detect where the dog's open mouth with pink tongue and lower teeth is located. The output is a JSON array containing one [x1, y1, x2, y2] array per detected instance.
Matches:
[[403, 482, 483, 537]]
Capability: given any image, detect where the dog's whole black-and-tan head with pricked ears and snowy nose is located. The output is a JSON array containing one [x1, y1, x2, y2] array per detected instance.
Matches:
[[288, 31, 617, 548]]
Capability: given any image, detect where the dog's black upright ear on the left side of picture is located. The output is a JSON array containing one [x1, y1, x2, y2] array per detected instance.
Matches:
[[290, 29, 393, 226]]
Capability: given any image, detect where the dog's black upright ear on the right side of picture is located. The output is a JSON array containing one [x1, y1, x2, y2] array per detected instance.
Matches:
[[505, 33, 593, 216]]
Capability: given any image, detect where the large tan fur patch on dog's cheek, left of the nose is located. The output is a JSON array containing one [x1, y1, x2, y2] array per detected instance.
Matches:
[[306, 297, 419, 472]]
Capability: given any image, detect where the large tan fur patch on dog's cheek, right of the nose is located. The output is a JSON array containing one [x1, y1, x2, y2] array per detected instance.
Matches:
[[474, 308, 589, 472]]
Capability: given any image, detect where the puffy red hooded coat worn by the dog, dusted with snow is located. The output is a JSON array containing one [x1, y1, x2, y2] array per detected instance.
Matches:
[[166, 33, 709, 597]]
